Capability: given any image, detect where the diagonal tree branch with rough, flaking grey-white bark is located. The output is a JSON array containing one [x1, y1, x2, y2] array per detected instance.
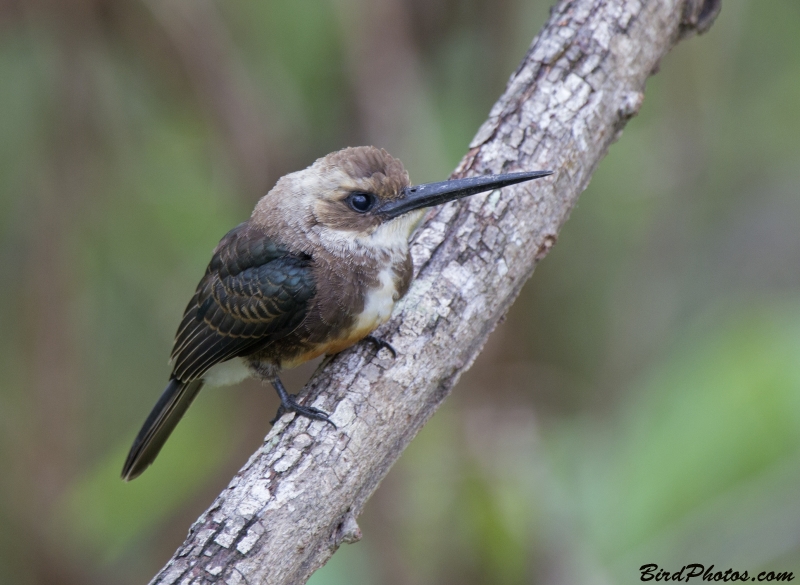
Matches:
[[152, 0, 720, 585]]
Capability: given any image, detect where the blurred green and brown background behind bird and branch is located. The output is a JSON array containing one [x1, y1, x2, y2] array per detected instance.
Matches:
[[0, 0, 800, 585]]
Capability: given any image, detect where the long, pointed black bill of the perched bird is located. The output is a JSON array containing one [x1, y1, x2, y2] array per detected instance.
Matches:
[[375, 171, 553, 219]]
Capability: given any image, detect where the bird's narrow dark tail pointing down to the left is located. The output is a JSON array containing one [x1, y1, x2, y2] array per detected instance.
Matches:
[[122, 378, 203, 481]]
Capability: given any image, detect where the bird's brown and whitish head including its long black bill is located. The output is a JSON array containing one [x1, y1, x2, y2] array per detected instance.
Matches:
[[253, 146, 551, 249]]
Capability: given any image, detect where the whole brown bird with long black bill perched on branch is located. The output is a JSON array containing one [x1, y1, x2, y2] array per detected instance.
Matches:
[[122, 146, 552, 481]]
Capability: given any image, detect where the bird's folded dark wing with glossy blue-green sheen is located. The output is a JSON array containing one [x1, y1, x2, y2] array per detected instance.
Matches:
[[171, 223, 316, 382]]
